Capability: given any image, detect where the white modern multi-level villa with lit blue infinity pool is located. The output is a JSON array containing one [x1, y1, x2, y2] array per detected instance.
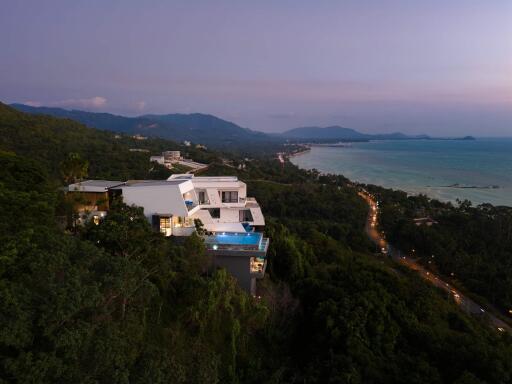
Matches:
[[68, 174, 269, 294]]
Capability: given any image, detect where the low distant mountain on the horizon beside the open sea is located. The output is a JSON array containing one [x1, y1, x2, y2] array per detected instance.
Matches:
[[281, 125, 430, 140]]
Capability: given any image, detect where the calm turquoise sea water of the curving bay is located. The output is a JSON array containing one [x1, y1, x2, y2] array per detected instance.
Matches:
[[291, 139, 512, 206]]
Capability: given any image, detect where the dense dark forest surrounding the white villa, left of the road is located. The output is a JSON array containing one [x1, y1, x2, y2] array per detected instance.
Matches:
[[0, 103, 512, 384]]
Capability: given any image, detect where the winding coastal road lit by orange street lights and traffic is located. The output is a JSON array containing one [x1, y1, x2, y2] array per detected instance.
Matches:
[[359, 191, 512, 332]]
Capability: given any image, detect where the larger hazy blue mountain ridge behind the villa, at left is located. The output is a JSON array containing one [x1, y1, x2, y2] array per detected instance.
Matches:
[[11, 104, 276, 148]]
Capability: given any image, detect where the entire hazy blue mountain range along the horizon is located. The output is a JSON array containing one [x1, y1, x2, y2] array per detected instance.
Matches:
[[11, 104, 444, 149]]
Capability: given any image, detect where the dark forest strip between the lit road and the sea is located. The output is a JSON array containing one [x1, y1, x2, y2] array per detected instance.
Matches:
[[369, 186, 512, 314]]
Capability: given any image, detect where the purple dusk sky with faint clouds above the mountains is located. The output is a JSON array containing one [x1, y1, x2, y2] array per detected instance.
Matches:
[[0, 0, 512, 136]]
